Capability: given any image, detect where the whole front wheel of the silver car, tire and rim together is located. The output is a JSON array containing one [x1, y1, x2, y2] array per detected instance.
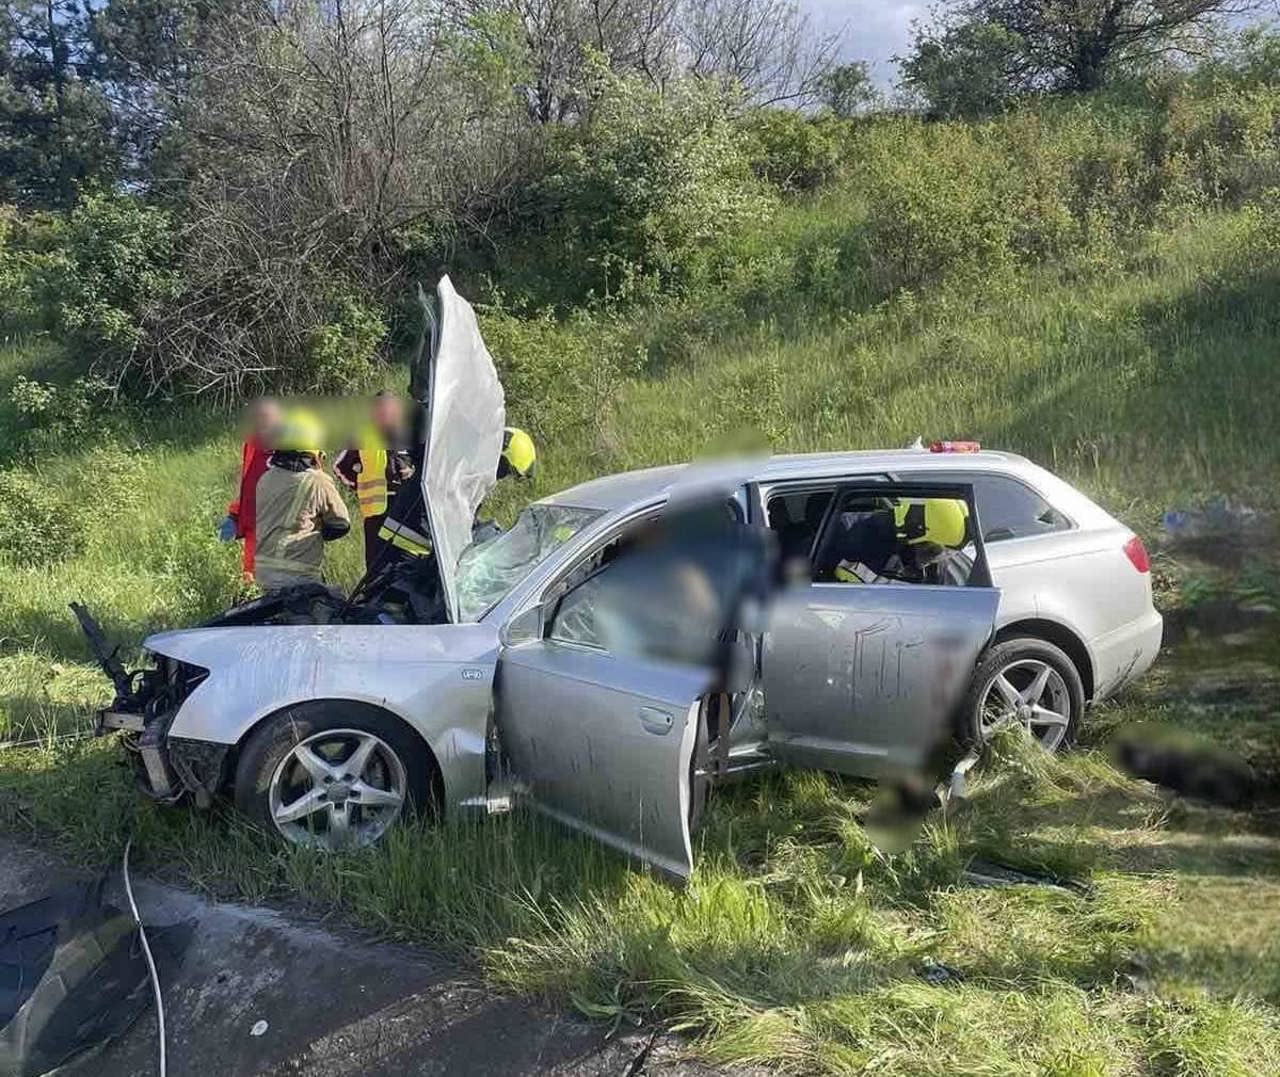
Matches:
[[236, 700, 433, 850]]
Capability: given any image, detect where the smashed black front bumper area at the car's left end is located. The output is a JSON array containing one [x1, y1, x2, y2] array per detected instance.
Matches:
[[72, 606, 230, 807]]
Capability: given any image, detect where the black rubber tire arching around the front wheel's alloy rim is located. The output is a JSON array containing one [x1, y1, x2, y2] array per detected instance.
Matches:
[[234, 699, 440, 840]]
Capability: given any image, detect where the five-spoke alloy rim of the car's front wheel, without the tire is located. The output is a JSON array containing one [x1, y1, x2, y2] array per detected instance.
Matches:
[[268, 729, 408, 849]]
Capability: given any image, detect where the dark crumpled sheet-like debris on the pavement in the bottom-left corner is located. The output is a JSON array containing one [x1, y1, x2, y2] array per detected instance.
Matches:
[[0, 876, 191, 1077]]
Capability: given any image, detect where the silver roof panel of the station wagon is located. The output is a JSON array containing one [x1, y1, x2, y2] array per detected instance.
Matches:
[[543, 448, 1039, 512]]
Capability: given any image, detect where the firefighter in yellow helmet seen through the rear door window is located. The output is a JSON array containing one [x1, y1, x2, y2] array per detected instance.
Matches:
[[814, 497, 972, 583]]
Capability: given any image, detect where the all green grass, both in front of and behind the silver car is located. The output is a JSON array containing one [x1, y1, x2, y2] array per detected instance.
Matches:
[[0, 197, 1280, 1077]]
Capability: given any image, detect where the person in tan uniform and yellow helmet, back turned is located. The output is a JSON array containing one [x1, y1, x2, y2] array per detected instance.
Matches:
[[253, 411, 351, 590]]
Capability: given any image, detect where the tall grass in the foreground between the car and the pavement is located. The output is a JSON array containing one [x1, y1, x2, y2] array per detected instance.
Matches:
[[0, 739, 1280, 1074]]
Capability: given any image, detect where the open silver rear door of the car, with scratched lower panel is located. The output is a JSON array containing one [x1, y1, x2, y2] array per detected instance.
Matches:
[[762, 483, 1000, 777]]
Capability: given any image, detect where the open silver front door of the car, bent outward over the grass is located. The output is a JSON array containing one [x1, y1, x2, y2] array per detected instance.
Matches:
[[495, 550, 710, 877]]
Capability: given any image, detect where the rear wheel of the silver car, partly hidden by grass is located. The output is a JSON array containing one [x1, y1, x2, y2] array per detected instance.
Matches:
[[961, 636, 1084, 752]]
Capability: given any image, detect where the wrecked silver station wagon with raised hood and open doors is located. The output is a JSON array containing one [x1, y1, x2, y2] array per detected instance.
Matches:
[[85, 279, 1161, 876]]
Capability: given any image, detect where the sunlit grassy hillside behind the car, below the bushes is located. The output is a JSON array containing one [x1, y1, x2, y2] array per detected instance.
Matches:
[[0, 196, 1280, 681]]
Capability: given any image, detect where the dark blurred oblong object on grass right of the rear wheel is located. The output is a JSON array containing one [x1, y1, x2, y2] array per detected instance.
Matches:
[[1111, 722, 1258, 808]]
